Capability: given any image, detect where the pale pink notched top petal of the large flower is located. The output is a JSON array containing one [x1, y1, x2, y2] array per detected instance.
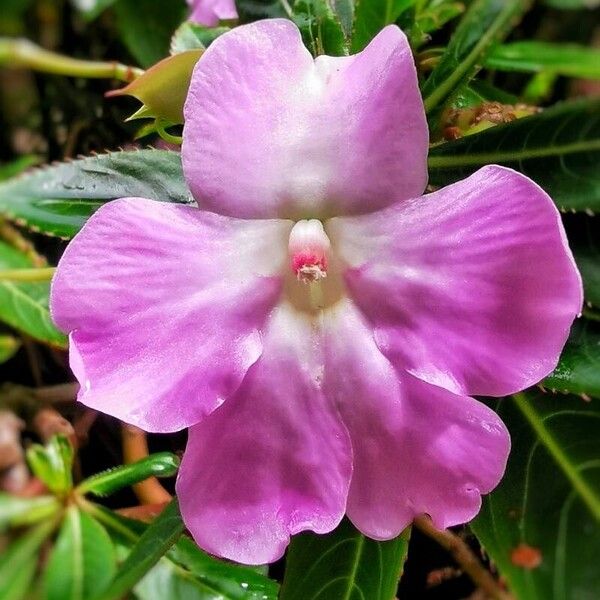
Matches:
[[182, 19, 428, 219]]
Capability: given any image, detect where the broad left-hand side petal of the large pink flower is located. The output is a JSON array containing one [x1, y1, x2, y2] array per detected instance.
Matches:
[[51, 198, 291, 432]]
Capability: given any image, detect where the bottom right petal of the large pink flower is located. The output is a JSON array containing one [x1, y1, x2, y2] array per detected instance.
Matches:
[[324, 303, 510, 540]]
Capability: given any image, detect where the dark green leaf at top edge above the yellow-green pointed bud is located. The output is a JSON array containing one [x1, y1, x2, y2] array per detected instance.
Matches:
[[114, 0, 188, 68]]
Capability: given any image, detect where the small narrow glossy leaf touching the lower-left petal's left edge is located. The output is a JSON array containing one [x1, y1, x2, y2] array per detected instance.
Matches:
[[77, 452, 179, 496]]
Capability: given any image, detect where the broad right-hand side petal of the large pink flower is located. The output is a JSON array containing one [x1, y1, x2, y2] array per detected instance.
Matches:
[[327, 166, 582, 396]]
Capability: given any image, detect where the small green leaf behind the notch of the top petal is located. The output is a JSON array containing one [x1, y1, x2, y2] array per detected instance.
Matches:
[[294, 0, 348, 56]]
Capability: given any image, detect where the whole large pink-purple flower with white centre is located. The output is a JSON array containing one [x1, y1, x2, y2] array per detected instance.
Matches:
[[52, 20, 582, 563]]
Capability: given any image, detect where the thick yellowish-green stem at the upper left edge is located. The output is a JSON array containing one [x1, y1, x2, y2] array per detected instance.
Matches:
[[0, 38, 144, 82]]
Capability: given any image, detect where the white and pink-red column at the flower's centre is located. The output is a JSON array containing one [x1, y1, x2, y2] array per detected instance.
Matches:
[[288, 219, 331, 284]]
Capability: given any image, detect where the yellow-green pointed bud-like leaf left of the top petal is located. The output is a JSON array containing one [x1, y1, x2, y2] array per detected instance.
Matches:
[[107, 49, 203, 125]]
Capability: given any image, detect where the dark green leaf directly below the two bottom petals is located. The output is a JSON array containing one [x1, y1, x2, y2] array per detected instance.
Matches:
[[280, 519, 409, 600]]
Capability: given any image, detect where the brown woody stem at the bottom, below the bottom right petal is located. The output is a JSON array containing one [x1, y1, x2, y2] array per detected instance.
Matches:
[[414, 516, 513, 600]]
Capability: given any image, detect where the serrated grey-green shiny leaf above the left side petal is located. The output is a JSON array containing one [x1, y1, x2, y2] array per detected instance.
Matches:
[[0, 150, 193, 237]]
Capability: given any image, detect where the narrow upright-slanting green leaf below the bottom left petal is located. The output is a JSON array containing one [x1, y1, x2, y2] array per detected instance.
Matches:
[[94, 500, 184, 600]]
